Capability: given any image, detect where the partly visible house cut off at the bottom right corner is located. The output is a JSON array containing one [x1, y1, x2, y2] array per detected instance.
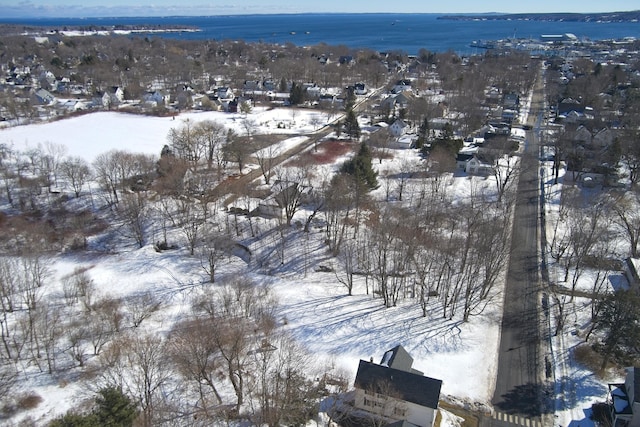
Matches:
[[609, 367, 640, 427]]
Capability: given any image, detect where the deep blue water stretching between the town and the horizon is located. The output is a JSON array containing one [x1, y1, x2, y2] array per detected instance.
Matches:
[[0, 14, 640, 54]]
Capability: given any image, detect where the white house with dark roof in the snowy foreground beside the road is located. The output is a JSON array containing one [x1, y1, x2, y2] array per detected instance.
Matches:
[[354, 345, 442, 427]]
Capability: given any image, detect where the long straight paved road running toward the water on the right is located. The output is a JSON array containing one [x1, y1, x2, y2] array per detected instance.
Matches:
[[491, 67, 544, 426]]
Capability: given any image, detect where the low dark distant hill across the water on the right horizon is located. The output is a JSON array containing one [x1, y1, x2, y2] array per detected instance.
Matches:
[[438, 10, 640, 22]]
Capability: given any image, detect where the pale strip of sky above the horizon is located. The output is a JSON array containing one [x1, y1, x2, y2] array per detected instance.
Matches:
[[0, 0, 640, 19]]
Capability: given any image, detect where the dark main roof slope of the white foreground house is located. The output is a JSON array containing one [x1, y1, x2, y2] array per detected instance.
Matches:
[[355, 360, 442, 409]]
